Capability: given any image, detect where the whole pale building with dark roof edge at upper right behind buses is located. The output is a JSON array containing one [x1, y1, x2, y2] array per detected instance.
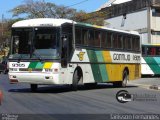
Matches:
[[99, 0, 160, 44]]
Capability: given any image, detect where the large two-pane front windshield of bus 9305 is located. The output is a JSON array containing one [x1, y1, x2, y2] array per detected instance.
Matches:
[[10, 27, 60, 59]]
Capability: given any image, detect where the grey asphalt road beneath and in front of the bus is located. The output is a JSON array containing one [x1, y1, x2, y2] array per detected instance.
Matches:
[[0, 74, 160, 118]]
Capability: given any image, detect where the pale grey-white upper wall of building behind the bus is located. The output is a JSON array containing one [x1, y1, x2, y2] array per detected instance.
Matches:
[[106, 9, 148, 44]]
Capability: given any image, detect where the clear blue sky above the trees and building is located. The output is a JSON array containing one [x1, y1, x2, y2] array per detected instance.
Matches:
[[0, 0, 108, 19]]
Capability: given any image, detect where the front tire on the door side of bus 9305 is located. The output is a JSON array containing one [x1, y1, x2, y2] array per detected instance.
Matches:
[[71, 70, 79, 91]]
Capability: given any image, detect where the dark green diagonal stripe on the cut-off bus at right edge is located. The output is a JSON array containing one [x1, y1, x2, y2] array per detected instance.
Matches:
[[144, 57, 160, 74]]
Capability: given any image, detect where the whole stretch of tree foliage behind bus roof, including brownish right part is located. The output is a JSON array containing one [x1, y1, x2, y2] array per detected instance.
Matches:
[[10, 0, 104, 25]]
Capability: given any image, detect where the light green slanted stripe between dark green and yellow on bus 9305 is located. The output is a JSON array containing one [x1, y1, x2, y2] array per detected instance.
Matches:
[[96, 51, 108, 82]]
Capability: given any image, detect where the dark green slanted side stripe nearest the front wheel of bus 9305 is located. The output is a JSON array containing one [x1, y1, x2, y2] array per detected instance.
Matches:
[[87, 50, 102, 82]]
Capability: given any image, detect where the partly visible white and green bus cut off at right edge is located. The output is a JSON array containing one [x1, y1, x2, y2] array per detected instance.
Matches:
[[141, 44, 160, 76]]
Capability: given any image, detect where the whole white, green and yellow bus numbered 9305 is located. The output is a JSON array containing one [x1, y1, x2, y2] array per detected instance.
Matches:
[[8, 18, 141, 91]]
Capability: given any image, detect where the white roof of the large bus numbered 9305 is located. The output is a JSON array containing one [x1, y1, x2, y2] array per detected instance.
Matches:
[[12, 18, 139, 35]]
